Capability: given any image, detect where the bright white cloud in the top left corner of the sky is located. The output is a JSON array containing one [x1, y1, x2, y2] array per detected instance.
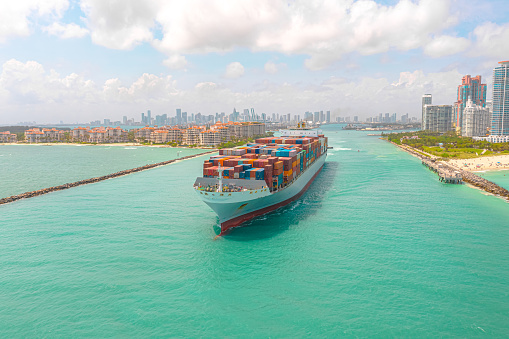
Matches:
[[0, 0, 69, 43]]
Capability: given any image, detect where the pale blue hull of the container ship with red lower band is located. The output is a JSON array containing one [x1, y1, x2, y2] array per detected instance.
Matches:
[[198, 153, 327, 235]]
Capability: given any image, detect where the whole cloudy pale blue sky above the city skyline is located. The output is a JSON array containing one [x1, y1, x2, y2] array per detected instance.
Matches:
[[0, 0, 509, 124]]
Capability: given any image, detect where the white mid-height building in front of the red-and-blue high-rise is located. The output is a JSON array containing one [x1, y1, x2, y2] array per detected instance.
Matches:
[[461, 99, 491, 137]]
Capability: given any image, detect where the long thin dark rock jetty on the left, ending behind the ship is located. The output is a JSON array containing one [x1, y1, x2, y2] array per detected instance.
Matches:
[[0, 150, 217, 205]]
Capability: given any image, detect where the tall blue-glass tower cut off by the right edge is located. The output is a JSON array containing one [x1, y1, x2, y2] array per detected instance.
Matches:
[[491, 61, 509, 136]]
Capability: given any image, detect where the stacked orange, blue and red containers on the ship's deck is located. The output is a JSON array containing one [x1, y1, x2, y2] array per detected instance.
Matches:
[[203, 135, 327, 190]]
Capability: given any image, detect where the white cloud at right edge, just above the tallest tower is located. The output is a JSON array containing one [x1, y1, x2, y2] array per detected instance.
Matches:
[[473, 22, 509, 60]]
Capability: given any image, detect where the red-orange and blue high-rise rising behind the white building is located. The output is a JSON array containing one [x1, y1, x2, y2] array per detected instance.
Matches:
[[454, 75, 486, 132]]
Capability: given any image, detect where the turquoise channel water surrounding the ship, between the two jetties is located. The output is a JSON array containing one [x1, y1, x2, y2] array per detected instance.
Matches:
[[0, 126, 509, 338]]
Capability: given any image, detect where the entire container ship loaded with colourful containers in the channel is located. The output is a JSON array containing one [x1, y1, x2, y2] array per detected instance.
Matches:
[[194, 126, 327, 235]]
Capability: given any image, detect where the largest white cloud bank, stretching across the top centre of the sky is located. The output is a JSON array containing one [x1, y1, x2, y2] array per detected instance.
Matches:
[[76, 0, 465, 69]]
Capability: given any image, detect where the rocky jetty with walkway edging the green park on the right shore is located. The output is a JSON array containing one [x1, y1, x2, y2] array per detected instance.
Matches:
[[391, 141, 509, 200]]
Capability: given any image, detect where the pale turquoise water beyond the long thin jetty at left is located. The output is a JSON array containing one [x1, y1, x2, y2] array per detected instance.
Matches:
[[0, 145, 204, 198]]
